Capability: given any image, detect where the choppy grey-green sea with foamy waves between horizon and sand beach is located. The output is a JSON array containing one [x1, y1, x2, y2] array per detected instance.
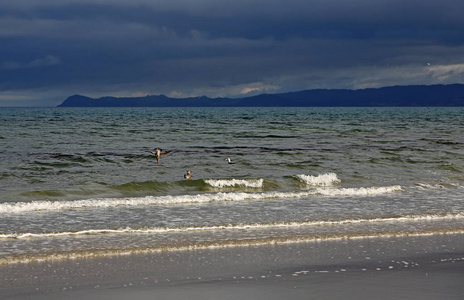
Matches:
[[0, 108, 464, 264]]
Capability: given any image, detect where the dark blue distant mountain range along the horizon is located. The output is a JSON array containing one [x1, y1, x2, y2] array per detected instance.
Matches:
[[58, 84, 464, 107]]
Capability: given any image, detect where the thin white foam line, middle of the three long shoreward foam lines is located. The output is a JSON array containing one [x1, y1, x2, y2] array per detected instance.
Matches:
[[0, 213, 464, 239]]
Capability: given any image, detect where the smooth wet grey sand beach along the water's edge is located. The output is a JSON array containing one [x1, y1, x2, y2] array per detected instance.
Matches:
[[0, 234, 464, 300]]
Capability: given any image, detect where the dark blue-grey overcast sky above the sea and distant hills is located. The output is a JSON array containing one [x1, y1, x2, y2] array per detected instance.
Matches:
[[0, 0, 464, 106]]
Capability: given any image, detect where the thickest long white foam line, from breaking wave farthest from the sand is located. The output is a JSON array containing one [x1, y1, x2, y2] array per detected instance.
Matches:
[[0, 185, 401, 214]]
